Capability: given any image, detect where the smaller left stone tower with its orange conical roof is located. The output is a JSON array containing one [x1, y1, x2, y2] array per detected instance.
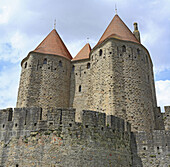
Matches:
[[17, 29, 72, 117]]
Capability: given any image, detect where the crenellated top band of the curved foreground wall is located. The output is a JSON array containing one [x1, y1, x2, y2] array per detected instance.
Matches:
[[0, 107, 131, 142]]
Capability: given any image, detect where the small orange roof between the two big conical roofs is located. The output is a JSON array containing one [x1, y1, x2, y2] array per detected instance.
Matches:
[[72, 43, 91, 61]]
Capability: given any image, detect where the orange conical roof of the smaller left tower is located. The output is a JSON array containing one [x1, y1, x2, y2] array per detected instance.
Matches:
[[33, 29, 72, 59]]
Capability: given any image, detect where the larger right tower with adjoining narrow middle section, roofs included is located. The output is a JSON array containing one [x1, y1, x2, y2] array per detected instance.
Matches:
[[70, 15, 156, 131]]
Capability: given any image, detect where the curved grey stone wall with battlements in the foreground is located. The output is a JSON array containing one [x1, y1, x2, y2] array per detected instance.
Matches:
[[0, 108, 132, 167]]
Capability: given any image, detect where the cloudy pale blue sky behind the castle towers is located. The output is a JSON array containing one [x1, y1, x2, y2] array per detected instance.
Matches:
[[0, 0, 170, 111]]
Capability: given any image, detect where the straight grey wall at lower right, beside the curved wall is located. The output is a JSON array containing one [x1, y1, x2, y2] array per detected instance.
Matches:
[[133, 130, 170, 167]]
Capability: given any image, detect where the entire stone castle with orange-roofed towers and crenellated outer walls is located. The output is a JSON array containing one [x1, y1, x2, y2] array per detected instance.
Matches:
[[0, 14, 170, 167]]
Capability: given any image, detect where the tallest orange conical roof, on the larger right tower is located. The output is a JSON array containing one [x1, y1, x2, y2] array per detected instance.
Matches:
[[97, 15, 139, 45]]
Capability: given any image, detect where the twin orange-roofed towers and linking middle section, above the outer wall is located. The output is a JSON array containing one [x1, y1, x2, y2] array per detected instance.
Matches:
[[17, 15, 158, 131]]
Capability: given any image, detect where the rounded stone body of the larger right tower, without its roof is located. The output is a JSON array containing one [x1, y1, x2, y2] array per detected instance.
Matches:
[[75, 39, 156, 131]]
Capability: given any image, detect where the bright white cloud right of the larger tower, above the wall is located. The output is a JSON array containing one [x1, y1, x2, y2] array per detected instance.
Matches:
[[155, 80, 170, 111]]
